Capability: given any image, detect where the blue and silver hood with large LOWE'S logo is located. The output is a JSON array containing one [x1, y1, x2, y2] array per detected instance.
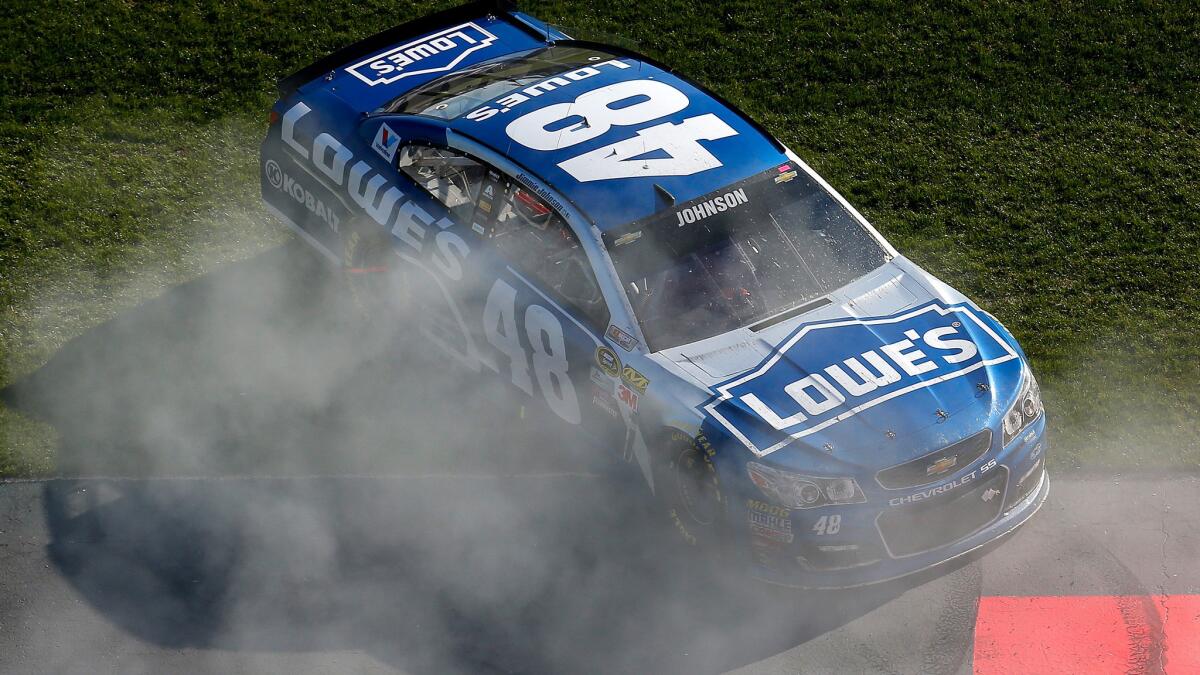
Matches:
[[664, 258, 1024, 472]]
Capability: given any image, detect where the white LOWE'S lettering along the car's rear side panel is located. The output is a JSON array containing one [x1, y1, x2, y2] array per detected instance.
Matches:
[[280, 103, 470, 281]]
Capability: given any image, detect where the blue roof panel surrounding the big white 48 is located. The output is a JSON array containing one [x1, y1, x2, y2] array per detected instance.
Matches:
[[446, 41, 787, 232]]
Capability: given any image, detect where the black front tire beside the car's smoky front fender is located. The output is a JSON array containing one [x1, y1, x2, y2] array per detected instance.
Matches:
[[654, 429, 730, 551]]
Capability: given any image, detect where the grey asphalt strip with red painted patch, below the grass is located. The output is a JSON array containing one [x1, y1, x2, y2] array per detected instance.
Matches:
[[0, 468, 1200, 674]]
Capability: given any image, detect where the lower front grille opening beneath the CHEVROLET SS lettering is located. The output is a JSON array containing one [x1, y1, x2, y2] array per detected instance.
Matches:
[[876, 466, 1008, 557]]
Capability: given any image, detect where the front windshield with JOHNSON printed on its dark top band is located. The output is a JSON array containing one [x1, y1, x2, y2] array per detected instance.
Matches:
[[604, 163, 887, 351]]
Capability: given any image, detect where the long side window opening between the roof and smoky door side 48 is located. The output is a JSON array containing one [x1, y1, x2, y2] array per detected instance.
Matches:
[[396, 145, 608, 331]]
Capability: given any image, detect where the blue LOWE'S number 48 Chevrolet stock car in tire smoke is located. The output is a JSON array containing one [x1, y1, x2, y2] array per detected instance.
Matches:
[[262, 1, 1049, 587]]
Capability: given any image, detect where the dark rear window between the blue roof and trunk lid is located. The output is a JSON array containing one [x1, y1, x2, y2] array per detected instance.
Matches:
[[386, 47, 612, 120]]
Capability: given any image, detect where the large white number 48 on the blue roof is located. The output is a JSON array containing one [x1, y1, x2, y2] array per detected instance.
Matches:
[[505, 79, 737, 183]]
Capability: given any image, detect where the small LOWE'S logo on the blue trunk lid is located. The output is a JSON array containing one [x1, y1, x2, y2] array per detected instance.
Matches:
[[346, 23, 496, 86]]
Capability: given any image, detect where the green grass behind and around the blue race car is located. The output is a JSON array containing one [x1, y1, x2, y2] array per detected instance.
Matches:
[[0, 0, 1200, 476]]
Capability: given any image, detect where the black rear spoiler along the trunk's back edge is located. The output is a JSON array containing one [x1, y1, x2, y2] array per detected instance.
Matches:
[[276, 0, 546, 98]]
